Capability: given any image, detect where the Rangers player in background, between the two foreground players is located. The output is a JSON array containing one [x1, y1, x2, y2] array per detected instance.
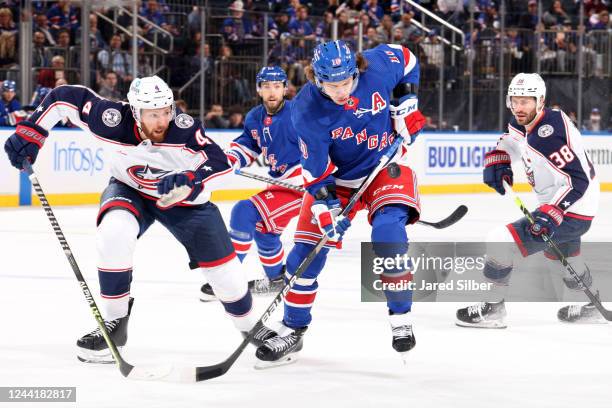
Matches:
[[201, 67, 303, 300]]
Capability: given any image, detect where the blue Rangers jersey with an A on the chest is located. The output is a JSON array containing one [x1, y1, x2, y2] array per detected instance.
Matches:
[[292, 44, 419, 187]]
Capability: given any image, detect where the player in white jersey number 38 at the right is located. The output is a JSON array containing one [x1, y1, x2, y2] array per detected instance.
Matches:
[[457, 73, 605, 328]]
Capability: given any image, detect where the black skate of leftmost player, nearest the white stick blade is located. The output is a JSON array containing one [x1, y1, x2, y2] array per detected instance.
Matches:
[[77, 298, 134, 364]]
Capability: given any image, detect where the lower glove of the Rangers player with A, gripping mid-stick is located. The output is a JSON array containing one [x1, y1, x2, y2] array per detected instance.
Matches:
[[311, 185, 351, 242]]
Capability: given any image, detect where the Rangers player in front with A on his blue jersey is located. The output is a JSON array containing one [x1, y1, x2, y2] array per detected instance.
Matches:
[[257, 41, 425, 366]]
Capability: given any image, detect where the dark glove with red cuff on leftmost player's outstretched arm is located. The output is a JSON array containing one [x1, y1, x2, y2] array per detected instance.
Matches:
[[4, 122, 49, 170]]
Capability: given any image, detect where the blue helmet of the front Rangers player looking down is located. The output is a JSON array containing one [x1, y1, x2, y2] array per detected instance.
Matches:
[[312, 40, 359, 86]]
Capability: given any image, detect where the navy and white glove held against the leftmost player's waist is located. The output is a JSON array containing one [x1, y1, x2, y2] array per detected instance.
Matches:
[[156, 171, 204, 210]]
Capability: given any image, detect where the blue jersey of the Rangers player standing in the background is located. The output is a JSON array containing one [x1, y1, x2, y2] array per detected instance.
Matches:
[[227, 101, 301, 182]]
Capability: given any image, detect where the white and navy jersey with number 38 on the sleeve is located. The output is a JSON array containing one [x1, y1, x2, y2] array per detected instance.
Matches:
[[497, 108, 600, 219]]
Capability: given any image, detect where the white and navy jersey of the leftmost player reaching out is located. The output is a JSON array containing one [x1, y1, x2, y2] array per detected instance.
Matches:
[[30, 85, 231, 205]]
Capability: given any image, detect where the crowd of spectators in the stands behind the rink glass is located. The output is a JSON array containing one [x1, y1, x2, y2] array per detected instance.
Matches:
[[0, 0, 612, 128]]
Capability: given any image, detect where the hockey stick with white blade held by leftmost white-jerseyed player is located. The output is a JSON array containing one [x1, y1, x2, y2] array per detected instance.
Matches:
[[23, 159, 171, 380]]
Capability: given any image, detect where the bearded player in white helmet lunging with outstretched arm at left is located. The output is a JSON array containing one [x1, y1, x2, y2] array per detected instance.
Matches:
[[4, 76, 274, 362]]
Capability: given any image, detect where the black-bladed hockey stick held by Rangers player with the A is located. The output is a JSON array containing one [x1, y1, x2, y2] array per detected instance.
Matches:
[[196, 135, 403, 381]]
